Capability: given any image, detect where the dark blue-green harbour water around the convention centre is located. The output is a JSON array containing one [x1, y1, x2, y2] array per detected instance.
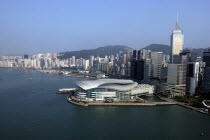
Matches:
[[0, 68, 210, 140]]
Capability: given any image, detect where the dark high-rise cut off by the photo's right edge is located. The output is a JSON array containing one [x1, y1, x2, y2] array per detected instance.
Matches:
[[202, 49, 210, 92]]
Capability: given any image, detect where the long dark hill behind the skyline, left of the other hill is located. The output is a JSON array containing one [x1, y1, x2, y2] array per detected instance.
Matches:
[[58, 45, 132, 59]]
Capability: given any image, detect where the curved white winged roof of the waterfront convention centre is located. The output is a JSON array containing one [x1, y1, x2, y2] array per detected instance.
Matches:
[[76, 79, 138, 91]]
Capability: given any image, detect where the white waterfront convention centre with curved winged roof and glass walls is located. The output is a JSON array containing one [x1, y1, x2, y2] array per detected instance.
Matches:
[[76, 79, 154, 101]]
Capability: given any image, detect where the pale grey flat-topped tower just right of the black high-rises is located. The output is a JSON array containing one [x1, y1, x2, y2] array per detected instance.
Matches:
[[151, 52, 163, 79]]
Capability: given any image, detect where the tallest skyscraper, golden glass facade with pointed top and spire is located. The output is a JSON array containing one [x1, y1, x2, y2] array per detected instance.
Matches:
[[171, 16, 184, 63]]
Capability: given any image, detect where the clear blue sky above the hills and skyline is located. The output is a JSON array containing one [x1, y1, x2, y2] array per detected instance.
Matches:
[[0, 0, 210, 55]]
